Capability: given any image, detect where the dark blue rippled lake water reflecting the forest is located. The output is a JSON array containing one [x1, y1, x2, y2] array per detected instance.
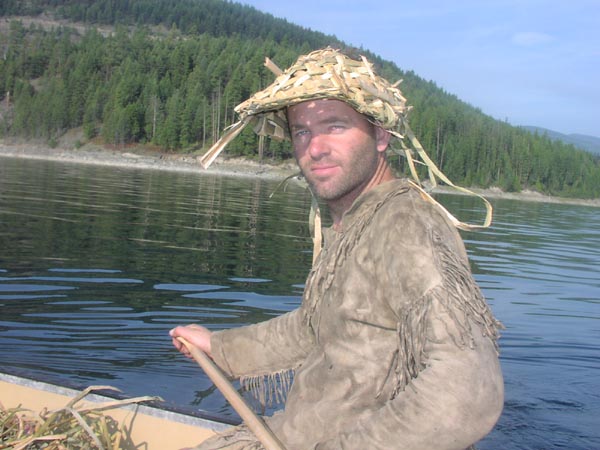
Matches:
[[0, 157, 600, 450]]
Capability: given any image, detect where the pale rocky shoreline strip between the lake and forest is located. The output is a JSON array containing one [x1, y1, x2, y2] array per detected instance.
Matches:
[[0, 142, 600, 207]]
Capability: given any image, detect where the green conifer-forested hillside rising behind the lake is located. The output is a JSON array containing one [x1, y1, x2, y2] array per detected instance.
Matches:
[[0, 0, 600, 198]]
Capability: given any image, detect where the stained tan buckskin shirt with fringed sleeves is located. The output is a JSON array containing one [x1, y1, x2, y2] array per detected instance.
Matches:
[[199, 180, 503, 450]]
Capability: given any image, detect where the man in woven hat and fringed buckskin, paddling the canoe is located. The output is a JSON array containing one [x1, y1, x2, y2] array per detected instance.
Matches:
[[171, 48, 503, 450]]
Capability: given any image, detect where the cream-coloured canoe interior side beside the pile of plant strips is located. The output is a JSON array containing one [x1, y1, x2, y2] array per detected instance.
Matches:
[[0, 372, 235, 450]]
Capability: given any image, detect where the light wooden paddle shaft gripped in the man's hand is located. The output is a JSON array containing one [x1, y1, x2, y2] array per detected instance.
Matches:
[[177, 337, 285, 450]]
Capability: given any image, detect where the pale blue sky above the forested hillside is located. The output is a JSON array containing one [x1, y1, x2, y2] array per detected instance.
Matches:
[[238, 0, 600, 137]]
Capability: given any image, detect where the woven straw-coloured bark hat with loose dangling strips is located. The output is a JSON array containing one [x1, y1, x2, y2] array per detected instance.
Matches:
[[200, 47, 492, 230]]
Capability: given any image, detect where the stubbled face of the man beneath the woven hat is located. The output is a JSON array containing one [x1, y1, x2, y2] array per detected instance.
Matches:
[[288, 100, 389, 203]]
